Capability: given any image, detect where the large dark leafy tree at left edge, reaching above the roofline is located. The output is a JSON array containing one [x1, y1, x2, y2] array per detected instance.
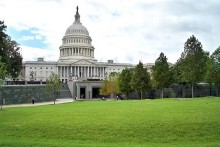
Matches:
[[0, 21, 22, 78]]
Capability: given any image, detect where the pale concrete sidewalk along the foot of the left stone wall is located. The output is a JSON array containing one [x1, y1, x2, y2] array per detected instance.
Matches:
[[2, 98, 74, 108]]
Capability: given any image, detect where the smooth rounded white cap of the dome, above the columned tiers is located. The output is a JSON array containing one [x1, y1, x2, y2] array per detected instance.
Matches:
[[65, 22, 89, 35]]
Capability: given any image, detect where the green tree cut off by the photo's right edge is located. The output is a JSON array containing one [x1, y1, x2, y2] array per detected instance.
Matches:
[[206, 47, 220, 95]]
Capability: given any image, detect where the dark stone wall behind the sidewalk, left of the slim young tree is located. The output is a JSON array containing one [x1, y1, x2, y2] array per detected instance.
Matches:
[[0, 85, 54, 105]]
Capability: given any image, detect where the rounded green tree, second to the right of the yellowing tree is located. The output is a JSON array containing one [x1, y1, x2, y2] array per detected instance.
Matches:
[[131, 62, 151, 99]]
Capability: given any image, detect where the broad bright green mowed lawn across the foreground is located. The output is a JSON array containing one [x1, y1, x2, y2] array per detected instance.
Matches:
[[0, 98, 220, 147]]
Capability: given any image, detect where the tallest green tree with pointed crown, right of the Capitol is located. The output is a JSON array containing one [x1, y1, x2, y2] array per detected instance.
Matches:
[[178, 35, 208, 97]]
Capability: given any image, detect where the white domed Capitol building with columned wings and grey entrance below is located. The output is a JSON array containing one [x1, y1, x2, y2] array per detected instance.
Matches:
[[21, 7, 140, 99]]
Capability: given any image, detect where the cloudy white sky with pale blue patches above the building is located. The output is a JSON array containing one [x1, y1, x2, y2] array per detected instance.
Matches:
[[0, 0, 220, 64]]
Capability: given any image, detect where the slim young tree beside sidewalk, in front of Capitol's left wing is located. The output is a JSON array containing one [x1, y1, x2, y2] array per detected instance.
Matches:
[[45, 72, 61, 104]]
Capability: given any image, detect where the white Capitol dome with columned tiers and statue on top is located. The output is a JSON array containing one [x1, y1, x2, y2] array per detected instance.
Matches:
[[60, 6, 96, 62]]
